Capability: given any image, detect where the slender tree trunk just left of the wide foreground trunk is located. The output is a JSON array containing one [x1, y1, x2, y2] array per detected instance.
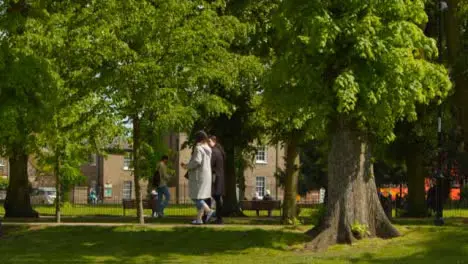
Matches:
[[282, 135, 299, 224]]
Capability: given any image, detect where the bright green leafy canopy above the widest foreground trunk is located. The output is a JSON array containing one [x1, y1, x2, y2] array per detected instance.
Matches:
[[271, 0, 451, 142]]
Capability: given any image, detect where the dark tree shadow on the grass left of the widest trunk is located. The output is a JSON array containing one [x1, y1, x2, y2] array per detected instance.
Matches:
[[0, 226, 307, 263]]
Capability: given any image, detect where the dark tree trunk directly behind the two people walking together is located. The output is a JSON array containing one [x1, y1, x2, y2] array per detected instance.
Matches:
[[222, 142, 244, 216]]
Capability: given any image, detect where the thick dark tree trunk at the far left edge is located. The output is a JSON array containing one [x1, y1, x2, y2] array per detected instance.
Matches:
[[4, 151, 39, 217]]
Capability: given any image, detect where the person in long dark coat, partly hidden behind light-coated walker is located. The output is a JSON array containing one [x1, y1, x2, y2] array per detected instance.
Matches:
[[209, 136, 226, 224]]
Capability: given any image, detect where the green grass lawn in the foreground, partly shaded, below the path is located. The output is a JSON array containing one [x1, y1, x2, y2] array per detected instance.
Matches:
[[0, 223, 468, 264]]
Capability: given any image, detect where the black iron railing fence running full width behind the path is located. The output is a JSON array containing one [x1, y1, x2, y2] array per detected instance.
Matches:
[[0, 186, 468, 218]]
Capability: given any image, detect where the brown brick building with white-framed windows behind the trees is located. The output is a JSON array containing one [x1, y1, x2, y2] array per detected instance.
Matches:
[[79, 133, 284, 203]]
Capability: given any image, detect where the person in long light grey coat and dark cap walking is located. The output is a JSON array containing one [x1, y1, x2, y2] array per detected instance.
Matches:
[[181, 131, 213, 225]]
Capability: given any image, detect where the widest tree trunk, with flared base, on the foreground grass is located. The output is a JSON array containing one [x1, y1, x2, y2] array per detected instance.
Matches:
[[307, 121, 400, 250]]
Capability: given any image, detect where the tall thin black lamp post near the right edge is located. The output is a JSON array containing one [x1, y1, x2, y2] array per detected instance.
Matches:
[[434, 0, 448, 226]]
